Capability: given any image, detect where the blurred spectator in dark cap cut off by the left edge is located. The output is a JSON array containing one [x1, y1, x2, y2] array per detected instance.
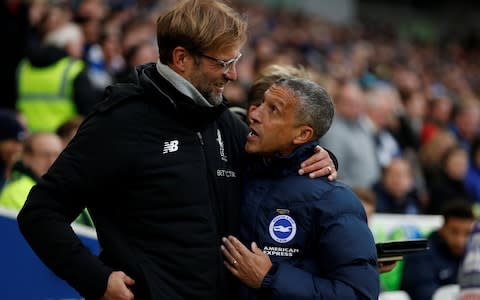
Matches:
[[0, 110, 26, 191]]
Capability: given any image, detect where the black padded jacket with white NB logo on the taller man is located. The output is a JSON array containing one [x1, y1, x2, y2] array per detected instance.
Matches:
[[18, 64, 247, 300]]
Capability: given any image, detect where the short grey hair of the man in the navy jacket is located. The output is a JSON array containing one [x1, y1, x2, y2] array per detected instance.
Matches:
[[275, 77, 335, 139]]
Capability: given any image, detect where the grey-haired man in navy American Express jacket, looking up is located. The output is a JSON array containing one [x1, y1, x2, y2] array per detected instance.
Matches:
[[221, 77, 379, 300]]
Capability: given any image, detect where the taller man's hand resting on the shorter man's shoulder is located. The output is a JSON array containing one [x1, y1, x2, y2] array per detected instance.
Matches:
[[298, 146, 337, 180]]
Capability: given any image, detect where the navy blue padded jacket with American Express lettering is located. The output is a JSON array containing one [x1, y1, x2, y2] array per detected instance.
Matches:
[[241, 142, 379, 299]]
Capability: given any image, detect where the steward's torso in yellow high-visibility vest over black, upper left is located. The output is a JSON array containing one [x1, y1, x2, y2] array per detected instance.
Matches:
[[16, 46, 101, 132]]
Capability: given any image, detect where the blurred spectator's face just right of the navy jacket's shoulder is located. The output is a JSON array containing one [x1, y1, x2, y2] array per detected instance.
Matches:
[[383, 159, 413, 199]]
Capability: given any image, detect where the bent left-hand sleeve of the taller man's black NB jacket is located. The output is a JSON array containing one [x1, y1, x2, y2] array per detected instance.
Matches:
[[17, 100, 140, 299]]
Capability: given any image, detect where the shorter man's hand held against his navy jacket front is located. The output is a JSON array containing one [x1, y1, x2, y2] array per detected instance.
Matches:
[[221, 236, 272, 289]]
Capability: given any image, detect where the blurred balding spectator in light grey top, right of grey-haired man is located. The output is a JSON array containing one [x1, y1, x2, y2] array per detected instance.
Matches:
[[320, 81, 381, 187]]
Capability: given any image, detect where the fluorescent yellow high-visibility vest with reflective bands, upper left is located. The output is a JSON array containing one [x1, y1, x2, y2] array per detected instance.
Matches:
[[16, 57, 84, 132]]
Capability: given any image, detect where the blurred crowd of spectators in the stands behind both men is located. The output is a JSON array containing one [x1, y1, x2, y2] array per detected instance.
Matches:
[[0, 0, 480, 298]]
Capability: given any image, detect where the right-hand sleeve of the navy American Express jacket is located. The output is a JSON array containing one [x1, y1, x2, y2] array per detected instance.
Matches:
[[262, 189, 379, 300]]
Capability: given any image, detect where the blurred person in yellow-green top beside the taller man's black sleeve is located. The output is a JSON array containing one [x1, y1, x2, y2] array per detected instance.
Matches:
[[0, 133, 63, 211]]
